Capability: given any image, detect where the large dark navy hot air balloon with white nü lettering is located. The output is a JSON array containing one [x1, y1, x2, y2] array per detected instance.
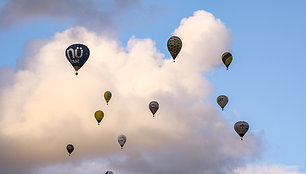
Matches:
[[66, 44, 89, 75]]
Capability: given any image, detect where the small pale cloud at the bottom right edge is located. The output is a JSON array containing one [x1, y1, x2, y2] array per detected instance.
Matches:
[[234, 164, 303, 174]]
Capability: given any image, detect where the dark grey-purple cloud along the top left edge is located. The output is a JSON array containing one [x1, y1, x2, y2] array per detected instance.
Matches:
[[0, 0, 141, 31]]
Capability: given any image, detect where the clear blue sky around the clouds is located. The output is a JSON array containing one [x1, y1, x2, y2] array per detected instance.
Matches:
[[0, 0, 306, 173]]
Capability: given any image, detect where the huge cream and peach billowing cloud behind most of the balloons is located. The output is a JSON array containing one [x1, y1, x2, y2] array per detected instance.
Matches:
[[0, 11, 261, 174]]
